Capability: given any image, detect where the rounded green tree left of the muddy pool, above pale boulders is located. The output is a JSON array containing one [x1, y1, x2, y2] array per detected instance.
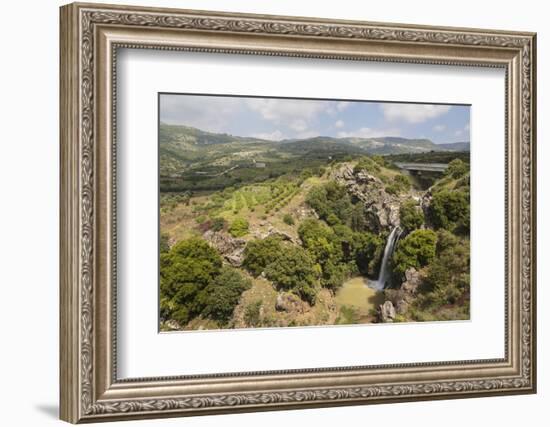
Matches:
[[265, 246, 318, 304]]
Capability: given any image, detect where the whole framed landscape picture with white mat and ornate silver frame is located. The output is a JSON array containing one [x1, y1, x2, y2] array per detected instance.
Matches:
[[60, 4, 536, 423]]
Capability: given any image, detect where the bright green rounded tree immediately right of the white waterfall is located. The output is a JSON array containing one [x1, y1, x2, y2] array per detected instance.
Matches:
[[392, 230, 437, 277]]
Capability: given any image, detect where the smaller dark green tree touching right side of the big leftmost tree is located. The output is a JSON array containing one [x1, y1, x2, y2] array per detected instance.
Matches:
[[197, 267, 252, 324]]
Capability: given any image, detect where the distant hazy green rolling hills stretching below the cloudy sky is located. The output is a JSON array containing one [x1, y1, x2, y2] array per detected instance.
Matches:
[[159, 123, 469, 191]]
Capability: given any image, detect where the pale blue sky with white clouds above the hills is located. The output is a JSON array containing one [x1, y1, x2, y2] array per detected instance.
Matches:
[[160, 94, 470, 144]]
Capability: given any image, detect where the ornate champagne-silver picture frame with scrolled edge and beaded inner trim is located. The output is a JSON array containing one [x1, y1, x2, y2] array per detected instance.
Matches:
[[60, 3, 536, 423]]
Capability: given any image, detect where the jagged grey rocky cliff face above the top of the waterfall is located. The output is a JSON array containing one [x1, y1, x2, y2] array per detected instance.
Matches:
[[332, 164, 401, 233]]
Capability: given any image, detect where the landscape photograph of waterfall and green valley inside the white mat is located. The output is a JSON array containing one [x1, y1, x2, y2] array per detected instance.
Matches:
[[158, 93, 470, 332]]
